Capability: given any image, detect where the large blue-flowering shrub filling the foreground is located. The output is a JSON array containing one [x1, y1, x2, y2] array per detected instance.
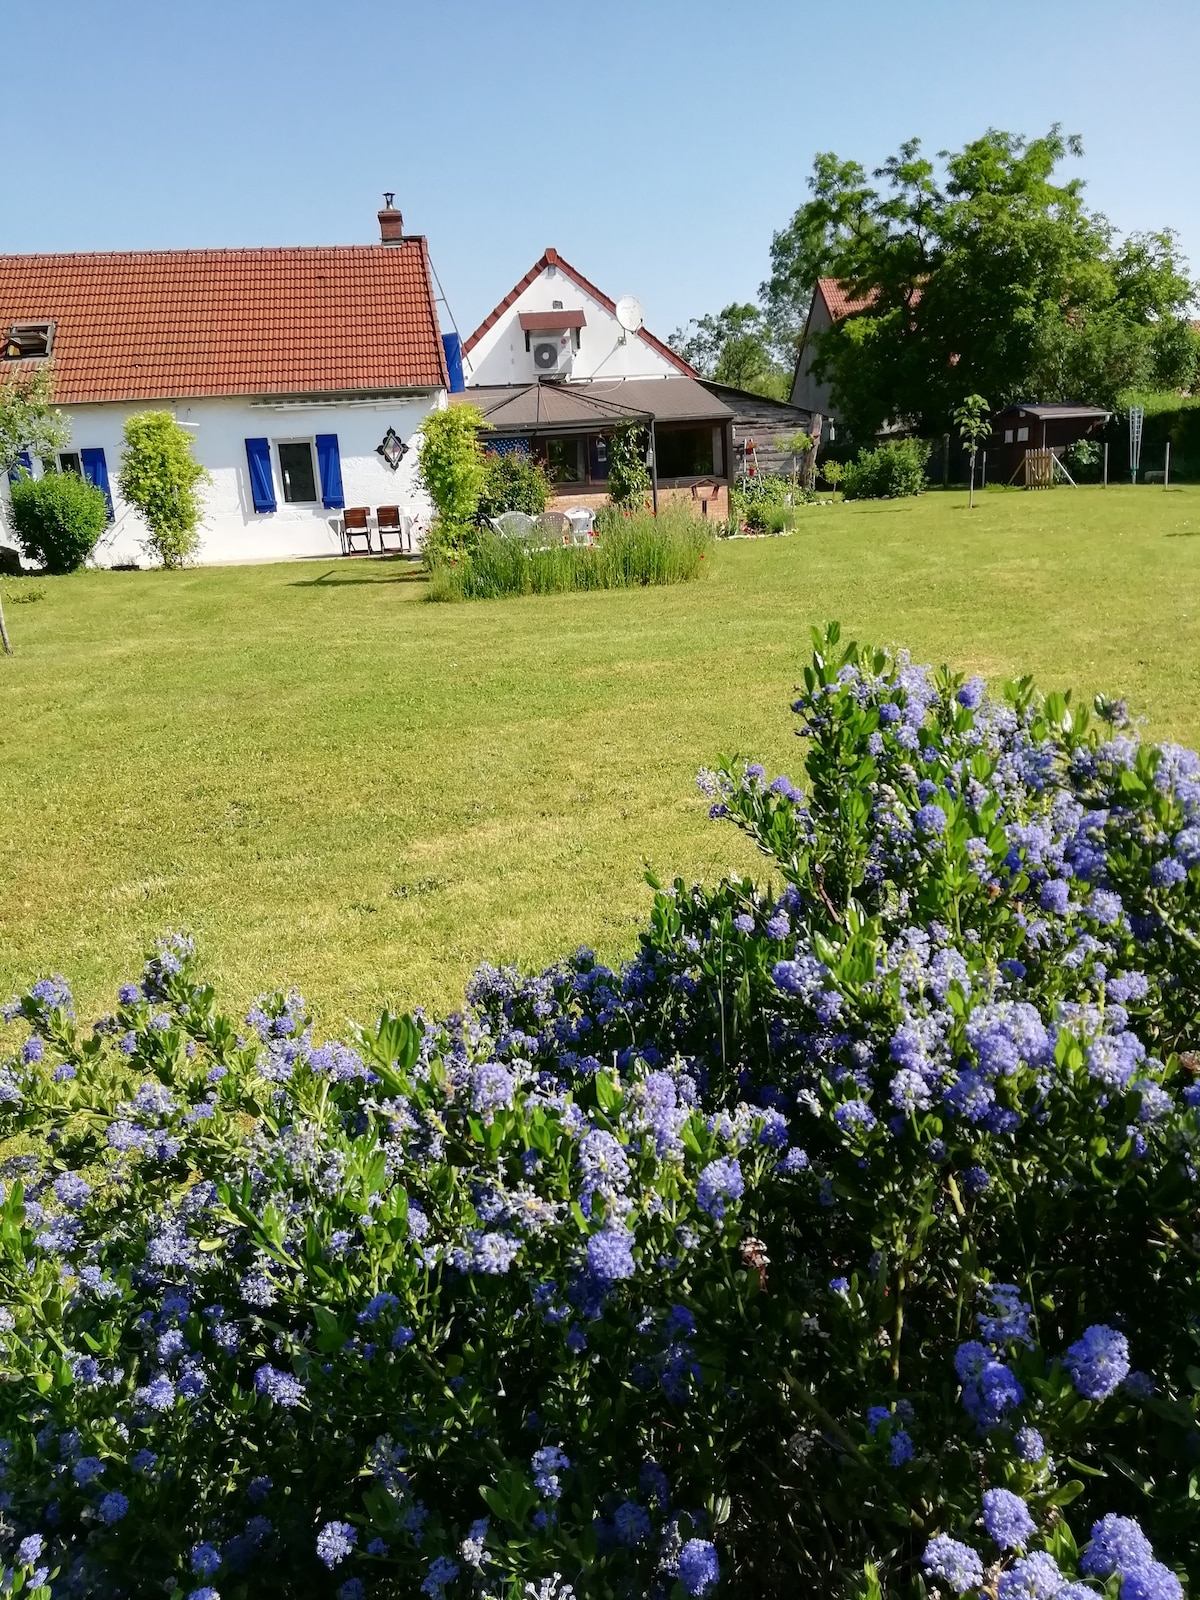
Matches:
[[0, 629, 1200, 1600]]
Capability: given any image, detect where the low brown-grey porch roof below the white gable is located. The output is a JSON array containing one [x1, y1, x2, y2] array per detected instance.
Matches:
[[450, 378, 733, 434]]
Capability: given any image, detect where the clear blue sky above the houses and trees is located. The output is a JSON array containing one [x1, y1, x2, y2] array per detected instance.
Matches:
[[0, 0, 1200, 336]]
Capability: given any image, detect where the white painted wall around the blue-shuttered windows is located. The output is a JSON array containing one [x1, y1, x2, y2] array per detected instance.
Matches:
[[0, 392, 446, 566]]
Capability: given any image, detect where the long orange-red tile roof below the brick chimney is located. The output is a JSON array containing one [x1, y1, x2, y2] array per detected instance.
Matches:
[[0, 237, 448, 405]]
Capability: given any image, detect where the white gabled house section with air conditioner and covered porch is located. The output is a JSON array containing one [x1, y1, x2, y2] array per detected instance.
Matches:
[[464, 250, 736, 517]]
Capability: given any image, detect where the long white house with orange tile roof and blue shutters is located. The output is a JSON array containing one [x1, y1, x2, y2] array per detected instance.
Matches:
[[0, 197, 448, 565]]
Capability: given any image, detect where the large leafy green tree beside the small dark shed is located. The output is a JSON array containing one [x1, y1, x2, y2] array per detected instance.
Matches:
[[774, 126, 1197, 434]]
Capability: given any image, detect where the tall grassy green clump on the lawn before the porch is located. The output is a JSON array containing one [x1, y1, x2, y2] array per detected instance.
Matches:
[[429, 507, 710, 600]]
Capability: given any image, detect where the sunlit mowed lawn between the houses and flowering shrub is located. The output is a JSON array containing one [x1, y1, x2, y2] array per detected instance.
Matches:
[[0, 488, 1200, 1027]]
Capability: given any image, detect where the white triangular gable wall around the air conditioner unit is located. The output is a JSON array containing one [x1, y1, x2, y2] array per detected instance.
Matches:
[[462, 266, 680, 389]]
